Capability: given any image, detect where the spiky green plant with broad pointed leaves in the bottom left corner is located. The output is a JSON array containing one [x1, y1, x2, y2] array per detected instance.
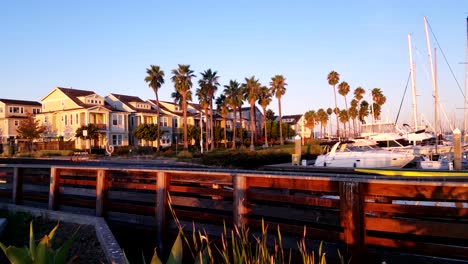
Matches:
[[0, 221, 79, 264]]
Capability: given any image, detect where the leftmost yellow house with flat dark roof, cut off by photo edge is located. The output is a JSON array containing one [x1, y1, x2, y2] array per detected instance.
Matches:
[[0, 99, 41, 143]]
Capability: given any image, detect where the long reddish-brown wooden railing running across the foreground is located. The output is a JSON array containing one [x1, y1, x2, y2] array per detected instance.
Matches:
[[0, 165, 468, 263]]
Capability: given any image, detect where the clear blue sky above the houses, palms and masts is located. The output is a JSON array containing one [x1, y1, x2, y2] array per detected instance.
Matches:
[[0, 0, 468, 130]]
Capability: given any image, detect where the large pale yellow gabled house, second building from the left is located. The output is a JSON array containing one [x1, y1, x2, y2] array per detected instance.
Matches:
[[37, 87, 129, 149]]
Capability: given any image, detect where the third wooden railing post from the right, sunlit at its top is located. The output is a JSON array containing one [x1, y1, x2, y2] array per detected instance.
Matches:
[[155, 171, 169, 252]]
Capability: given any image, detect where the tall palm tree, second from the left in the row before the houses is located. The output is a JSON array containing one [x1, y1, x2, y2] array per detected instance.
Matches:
[[171, 64, 195, 151]]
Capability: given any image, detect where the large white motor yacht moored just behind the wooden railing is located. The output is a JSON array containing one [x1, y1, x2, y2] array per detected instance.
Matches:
[[314, 141, 414, 168]]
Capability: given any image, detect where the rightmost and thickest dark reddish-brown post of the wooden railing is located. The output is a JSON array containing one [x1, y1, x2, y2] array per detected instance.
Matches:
[[340, 182, 366, 263]]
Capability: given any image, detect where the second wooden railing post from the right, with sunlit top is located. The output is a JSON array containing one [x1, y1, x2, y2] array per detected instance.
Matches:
[[232, 174, 248, 229]]
